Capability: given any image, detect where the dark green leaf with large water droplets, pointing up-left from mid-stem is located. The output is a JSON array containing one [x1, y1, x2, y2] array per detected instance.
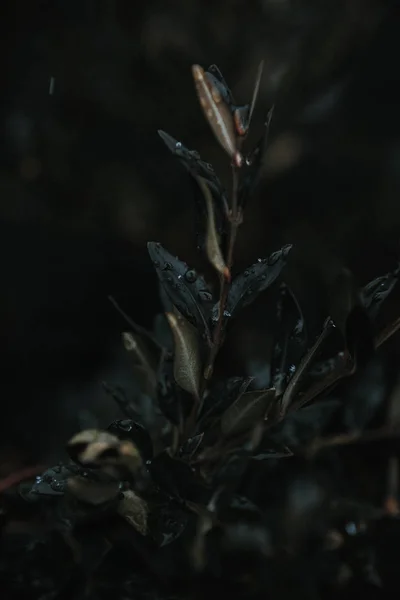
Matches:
[[147, 242, 213, 344]]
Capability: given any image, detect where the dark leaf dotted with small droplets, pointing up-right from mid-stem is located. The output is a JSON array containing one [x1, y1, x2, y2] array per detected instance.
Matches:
[[220, 244, 292, 318]]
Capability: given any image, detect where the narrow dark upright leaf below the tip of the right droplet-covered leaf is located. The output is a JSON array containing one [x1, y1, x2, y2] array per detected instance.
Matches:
[[271, 283, 308, 396]]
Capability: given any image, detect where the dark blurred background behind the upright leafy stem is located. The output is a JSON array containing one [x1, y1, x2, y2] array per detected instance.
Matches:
[[0, 0, 400, 474]]
